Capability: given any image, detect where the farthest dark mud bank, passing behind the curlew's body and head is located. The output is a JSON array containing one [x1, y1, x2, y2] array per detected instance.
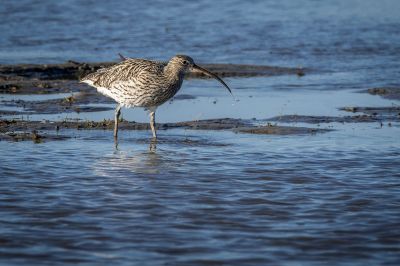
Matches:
[[0, 61, 308, 94]]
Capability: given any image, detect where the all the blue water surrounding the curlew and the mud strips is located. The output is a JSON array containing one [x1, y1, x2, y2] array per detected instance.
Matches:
[[0, 0, 400, 265]]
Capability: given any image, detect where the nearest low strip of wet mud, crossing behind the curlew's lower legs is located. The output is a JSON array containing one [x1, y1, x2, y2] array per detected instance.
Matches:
[[0, 118, 330, 141]]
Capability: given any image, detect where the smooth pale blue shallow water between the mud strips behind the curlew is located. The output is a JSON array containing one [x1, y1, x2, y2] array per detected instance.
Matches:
[[0, 74, 398, 123]]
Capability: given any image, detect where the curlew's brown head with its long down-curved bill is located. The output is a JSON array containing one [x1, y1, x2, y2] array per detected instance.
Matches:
[[168, 55, 232, 94]]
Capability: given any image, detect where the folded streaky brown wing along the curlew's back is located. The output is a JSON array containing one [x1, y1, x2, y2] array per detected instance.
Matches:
[[81, 59, 166, 88]]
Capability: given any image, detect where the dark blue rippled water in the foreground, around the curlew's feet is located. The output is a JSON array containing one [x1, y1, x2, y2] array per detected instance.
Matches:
[[0, 128, 400, 265]]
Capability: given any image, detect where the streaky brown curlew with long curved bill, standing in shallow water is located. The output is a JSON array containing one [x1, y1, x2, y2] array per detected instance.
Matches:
[[81, 55, 232, 140]]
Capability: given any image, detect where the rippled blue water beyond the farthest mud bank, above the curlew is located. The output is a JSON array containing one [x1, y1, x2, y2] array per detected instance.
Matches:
[[0, 0, 400, 70]]
